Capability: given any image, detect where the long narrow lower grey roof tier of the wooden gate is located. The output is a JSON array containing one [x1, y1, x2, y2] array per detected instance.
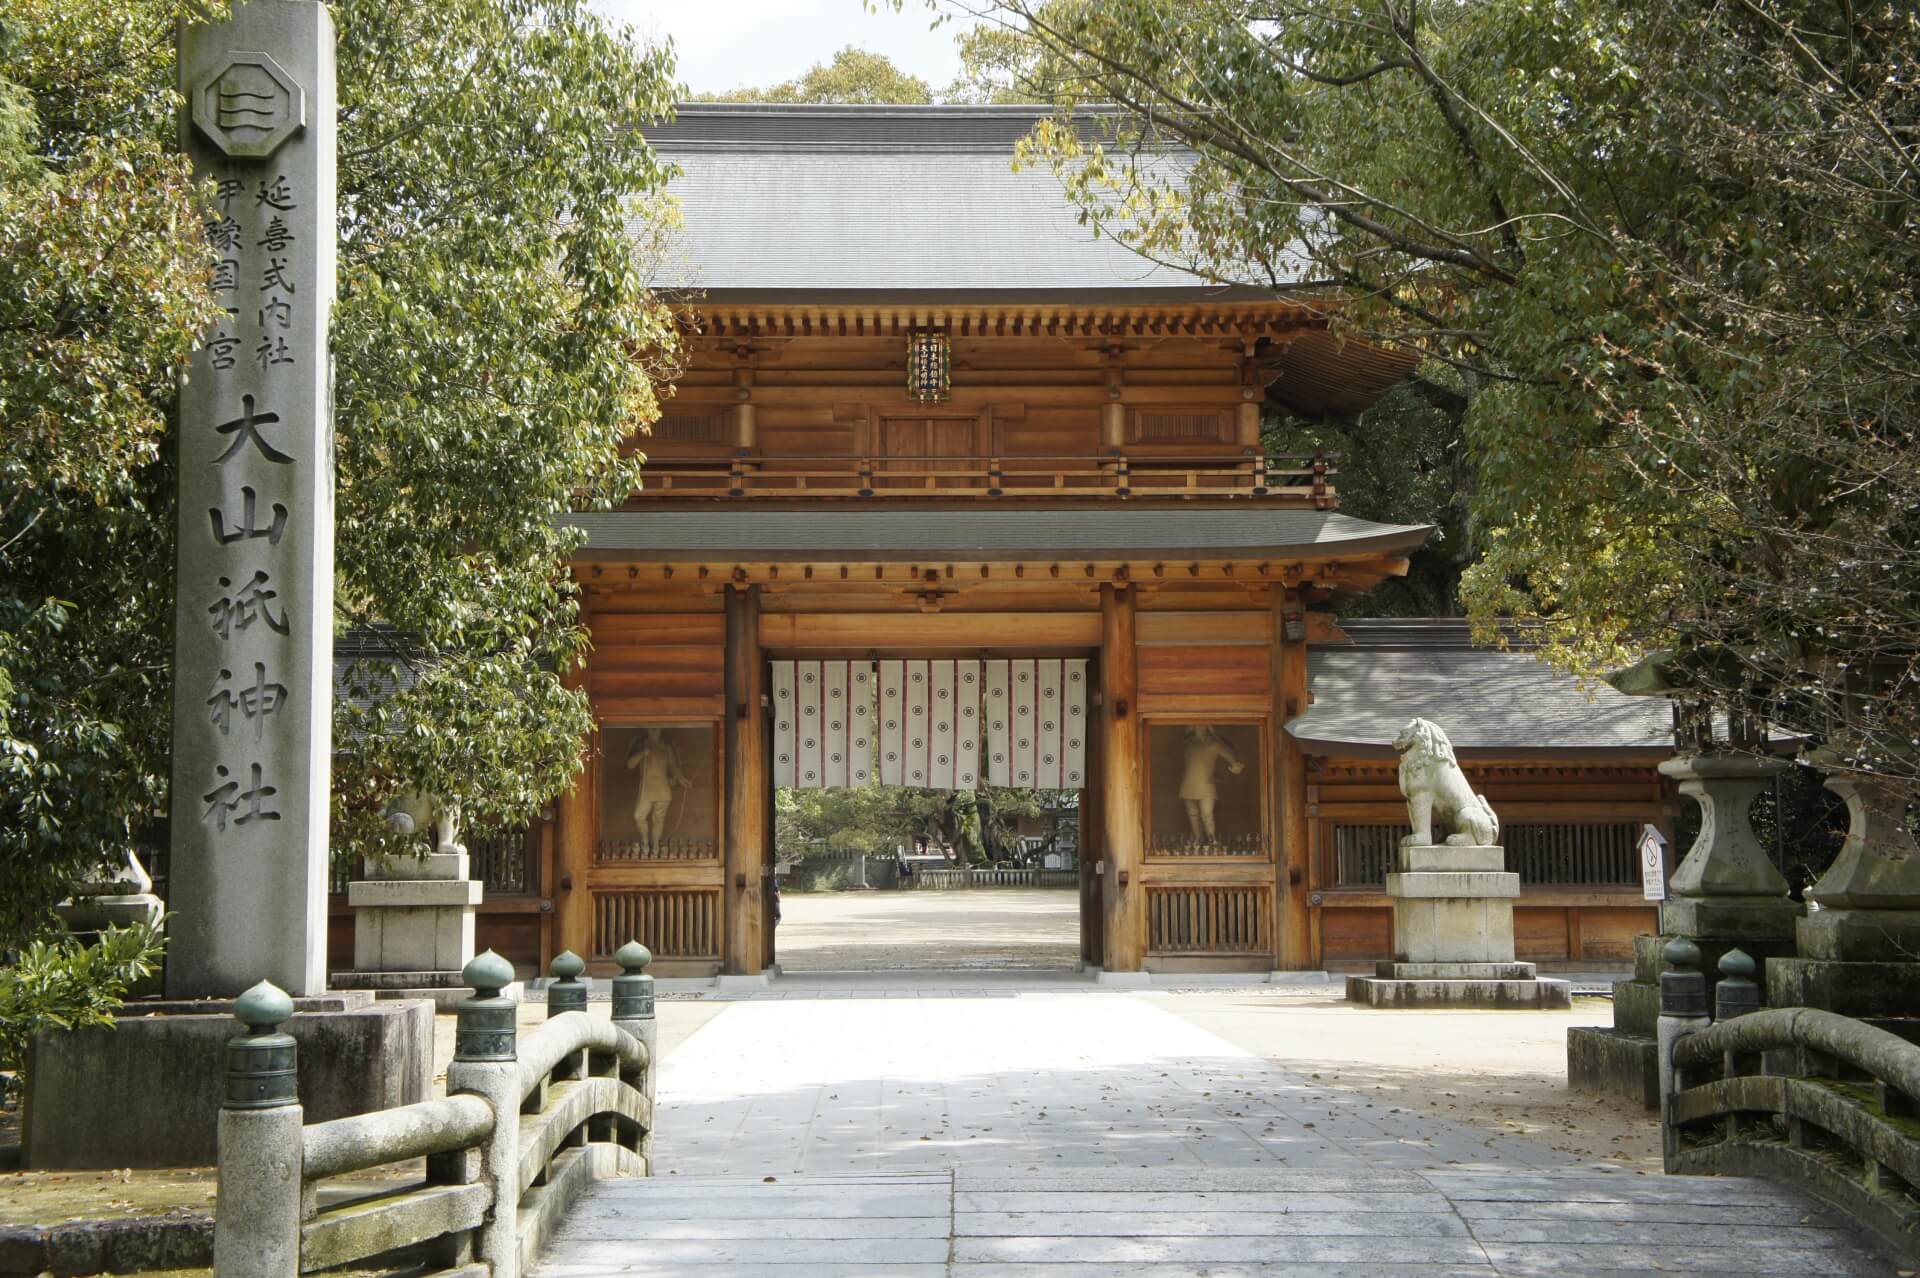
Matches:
[[564, 505, 1428, 562]]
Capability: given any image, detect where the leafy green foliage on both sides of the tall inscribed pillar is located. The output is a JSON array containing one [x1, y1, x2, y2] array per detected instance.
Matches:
[[0, 0, 672, 944]]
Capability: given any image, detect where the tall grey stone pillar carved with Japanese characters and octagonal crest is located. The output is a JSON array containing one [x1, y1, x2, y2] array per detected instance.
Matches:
[[167, 0, 336, 998]]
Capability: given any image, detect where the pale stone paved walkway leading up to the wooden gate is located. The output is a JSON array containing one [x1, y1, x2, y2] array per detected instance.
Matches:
[[538, 978, 1891, 1278]]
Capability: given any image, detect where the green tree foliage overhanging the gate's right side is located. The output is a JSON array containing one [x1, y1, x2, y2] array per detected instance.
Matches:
[[921, 0, 1920, 777]]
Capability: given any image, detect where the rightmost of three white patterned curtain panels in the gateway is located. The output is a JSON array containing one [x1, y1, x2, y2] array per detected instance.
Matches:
[[985, 658, 1089, 791]]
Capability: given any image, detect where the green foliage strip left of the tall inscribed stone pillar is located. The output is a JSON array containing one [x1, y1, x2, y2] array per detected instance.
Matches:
[[0, 0, 232, 950]]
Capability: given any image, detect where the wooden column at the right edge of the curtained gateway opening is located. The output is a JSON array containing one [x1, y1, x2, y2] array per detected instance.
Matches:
[[1100, 581, 1146, 971]]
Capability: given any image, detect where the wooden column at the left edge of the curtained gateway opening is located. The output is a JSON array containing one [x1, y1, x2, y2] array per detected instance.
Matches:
[[720, 585, 770, 977]]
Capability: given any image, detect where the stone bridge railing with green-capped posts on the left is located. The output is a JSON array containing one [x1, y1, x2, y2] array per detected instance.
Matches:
[[213, 944, 657, 1278]]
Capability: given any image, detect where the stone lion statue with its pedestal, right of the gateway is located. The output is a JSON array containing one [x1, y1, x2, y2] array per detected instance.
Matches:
[[1346, 720, 1572, 1009]]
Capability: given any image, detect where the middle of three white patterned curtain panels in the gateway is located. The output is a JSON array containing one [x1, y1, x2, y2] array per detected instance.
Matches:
[[874, 662, 981, 791]]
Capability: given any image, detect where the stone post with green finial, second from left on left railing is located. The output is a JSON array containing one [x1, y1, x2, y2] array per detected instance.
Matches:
[[447, 950, 520, 1278]]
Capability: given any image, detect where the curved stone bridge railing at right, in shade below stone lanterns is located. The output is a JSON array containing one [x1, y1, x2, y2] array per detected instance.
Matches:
[[1659, 940, 1920, 1263]]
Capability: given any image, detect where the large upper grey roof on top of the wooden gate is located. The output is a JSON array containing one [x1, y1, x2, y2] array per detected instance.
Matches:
[[647, 104, 1313, 291]]
